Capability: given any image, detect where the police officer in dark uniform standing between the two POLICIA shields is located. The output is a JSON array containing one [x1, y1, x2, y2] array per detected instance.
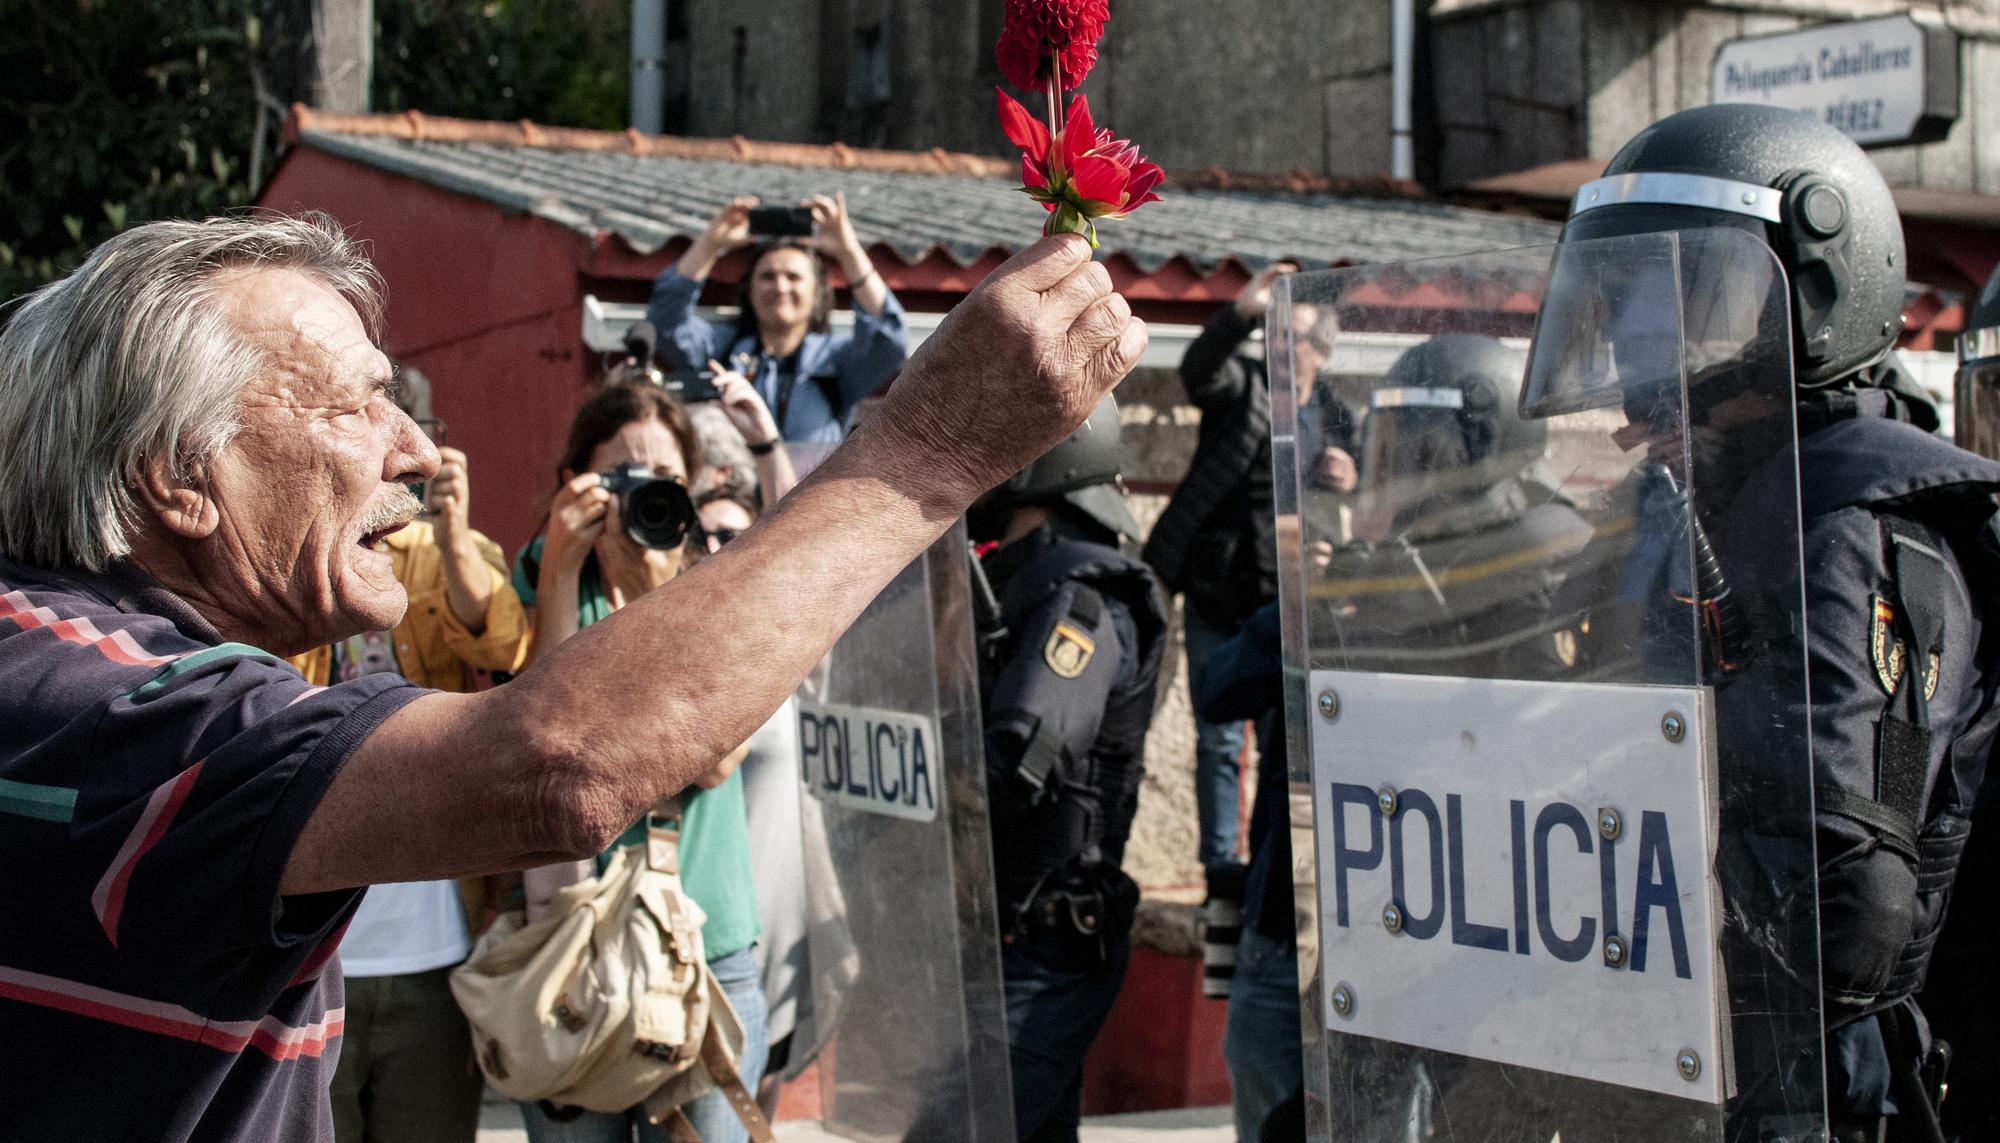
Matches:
[[968, 398, 1166, 1143]]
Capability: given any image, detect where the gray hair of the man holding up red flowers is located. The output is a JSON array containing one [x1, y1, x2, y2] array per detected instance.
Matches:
[[0, 212, 382, 572]]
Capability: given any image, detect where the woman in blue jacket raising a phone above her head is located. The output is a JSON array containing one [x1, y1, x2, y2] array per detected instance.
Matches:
[[646, 194, 908, 444]]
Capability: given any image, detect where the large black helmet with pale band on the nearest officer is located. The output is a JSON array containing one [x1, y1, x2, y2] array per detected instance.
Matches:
[[1562, 104, 1904, 388]]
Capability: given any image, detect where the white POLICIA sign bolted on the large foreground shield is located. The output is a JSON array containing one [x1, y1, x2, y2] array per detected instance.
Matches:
[[1308, 671, 1728, 1103]]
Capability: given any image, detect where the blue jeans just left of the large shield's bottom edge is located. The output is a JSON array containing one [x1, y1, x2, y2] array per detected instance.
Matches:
[[1222, 927, 1306, 1143]]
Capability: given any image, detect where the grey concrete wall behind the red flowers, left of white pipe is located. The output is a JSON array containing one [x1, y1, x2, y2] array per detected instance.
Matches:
[[686, 0, 1388, 176]]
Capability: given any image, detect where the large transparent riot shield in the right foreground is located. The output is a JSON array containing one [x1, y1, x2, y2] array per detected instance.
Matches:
[[1270, 230, 1826, 1143]]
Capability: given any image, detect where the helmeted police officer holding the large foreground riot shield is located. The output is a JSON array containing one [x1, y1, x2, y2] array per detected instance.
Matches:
[[1530, 104, 2000, 1143]]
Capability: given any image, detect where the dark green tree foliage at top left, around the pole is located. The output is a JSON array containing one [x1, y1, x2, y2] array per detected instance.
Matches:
[[0, 0, 628, 305]]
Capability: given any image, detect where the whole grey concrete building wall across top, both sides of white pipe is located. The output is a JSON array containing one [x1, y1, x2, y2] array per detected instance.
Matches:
[[674, 0, 2000, 194]]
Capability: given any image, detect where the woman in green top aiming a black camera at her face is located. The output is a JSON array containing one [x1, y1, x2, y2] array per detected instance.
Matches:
[[514, 382, 766, 1143]]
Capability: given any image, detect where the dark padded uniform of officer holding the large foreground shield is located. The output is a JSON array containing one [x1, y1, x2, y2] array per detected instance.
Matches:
[[1776, 418, 2000, 1113]]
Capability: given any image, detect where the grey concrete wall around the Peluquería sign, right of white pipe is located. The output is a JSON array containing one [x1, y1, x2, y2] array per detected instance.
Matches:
[[1432, 0, 2000, 194]]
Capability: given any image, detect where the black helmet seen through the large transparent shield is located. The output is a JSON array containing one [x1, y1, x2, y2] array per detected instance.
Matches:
[[1360, 334, 1548, 484]]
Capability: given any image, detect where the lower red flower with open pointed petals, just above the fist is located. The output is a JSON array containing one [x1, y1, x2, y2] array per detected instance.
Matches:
[[994, 88, 1164, 246]]
